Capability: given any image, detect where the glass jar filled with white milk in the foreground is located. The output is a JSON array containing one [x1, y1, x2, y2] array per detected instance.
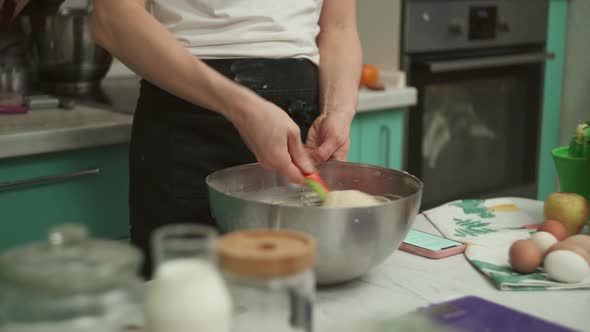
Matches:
[[144, 224, 231, 332]]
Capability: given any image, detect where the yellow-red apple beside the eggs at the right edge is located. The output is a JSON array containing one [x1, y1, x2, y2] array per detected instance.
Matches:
[[543, 192, 588, 236]]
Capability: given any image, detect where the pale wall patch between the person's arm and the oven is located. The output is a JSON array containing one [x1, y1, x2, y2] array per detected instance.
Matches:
[[357, 0, 401, 71]]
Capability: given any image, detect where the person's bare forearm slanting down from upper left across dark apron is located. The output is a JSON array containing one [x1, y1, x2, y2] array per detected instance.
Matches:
[[93, 0, 257, 119]]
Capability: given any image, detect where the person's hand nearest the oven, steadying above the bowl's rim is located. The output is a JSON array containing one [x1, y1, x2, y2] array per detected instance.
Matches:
[[305, 112, 354, 164]]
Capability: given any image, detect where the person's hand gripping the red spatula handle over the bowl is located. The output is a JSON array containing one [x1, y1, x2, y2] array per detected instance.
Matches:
[[230, 99, 316, 183]]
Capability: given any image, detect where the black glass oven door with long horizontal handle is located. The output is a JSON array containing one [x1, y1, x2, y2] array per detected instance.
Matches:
[[406, 48, 548, 209]]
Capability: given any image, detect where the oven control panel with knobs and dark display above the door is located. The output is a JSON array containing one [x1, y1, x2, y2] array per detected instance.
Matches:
[[403, 0, 549, 53]]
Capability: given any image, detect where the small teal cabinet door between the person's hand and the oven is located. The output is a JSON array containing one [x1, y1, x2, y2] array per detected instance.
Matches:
[[348, 109, 406, 169]]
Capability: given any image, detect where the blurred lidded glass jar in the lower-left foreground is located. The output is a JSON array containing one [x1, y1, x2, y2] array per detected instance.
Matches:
[[0, 224, 141, 332]]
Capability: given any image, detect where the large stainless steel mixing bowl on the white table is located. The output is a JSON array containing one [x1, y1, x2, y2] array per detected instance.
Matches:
[[207, 162, 423, 285]]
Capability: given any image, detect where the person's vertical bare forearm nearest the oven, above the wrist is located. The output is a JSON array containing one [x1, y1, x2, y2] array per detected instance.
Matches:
[[318, 27, 362, 117]]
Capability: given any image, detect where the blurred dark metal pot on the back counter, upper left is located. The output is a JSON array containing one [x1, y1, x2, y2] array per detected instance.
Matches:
[[21, 6, 112, 94]]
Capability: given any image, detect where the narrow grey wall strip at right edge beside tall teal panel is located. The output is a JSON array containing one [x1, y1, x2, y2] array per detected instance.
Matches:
[[560, 0, 590, 145]]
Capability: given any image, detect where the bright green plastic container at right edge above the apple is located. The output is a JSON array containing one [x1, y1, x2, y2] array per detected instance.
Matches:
[[552, 146, 590, 203]]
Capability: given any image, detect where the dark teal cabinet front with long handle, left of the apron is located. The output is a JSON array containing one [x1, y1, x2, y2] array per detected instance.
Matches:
[[0, 145, 129, 250]]
